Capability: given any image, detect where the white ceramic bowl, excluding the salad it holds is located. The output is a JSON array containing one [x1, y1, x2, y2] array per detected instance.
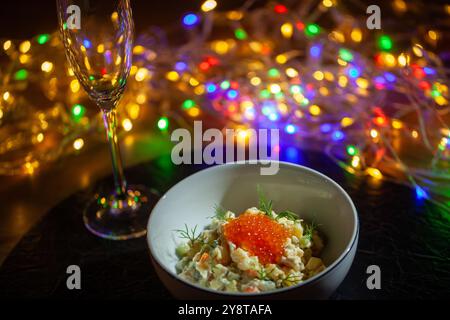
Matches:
[[147, 162, 359, 299]]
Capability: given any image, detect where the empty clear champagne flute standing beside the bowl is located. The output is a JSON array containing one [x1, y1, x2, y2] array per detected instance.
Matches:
[[57, 0, 157, 240]]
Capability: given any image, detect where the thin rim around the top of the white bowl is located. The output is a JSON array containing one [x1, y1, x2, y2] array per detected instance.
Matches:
[[146, 160, 360, 297]]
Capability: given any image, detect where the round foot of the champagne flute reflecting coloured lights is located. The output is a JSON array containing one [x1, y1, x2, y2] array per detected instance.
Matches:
[[83, 185, 159, 240]]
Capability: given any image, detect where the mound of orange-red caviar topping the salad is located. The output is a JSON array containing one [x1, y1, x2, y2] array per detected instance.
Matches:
[[224, 213, 291, 264]]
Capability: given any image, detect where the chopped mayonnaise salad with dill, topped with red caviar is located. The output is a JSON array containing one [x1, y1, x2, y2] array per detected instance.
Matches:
[[176, 202, 325, 293]]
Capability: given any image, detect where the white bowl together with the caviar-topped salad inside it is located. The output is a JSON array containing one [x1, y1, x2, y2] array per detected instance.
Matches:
[[147, 162, 359, 299]]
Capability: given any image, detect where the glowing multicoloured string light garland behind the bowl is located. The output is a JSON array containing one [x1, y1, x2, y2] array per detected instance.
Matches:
[[0, 0, 450, 215]]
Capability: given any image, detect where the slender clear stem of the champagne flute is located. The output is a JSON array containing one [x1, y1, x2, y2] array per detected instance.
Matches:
[[102, 108, 127, 199]]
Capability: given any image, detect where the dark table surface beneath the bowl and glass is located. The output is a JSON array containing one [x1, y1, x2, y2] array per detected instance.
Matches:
[[0, 150, 450, 299]]
